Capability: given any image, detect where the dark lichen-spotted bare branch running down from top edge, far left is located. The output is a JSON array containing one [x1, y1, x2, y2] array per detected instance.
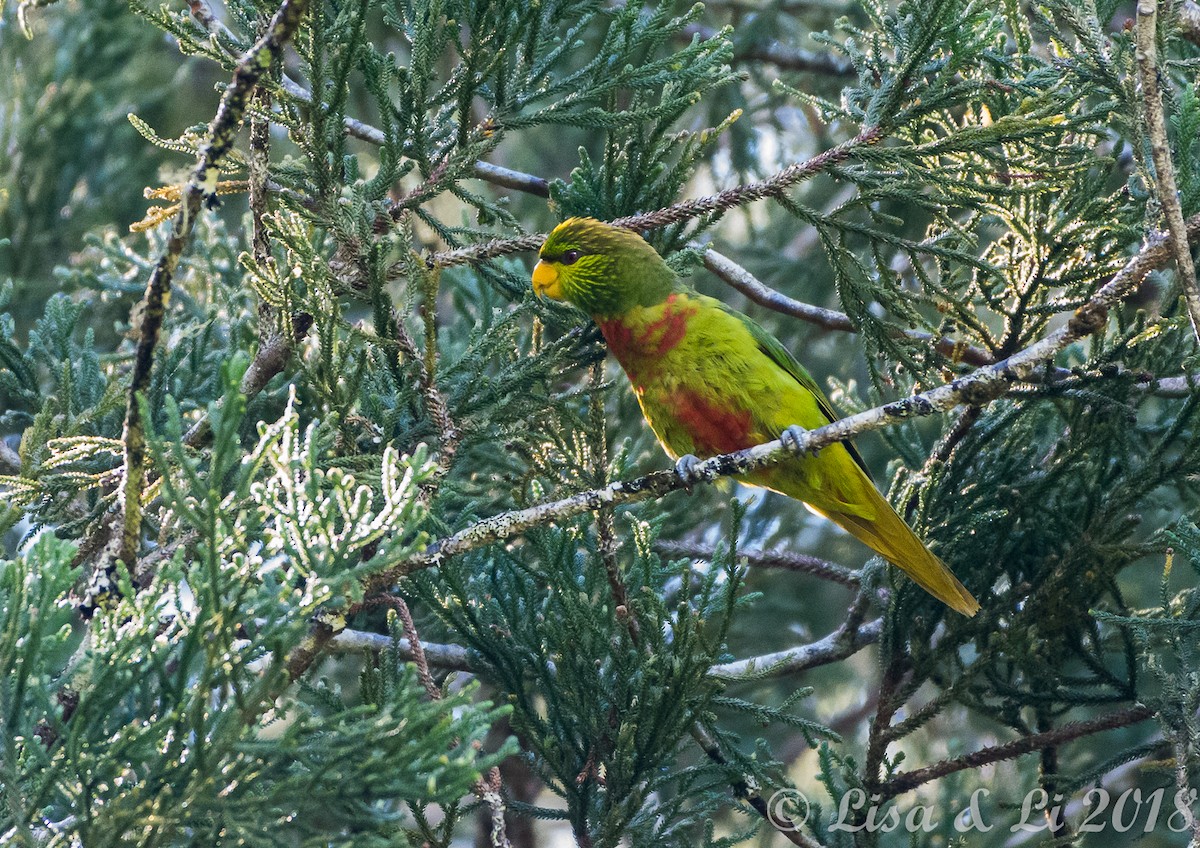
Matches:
[[115, 0, 307, 572]]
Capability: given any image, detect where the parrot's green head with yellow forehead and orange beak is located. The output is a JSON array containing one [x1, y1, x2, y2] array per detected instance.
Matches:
[[533, 218, 676, 317]]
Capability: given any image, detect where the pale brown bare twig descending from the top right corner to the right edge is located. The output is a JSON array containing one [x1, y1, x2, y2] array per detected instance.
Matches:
[[1134, 0, 1200, 341]]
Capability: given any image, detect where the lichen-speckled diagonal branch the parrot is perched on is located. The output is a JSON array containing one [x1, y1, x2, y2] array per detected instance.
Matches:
[[367, 216, 1200, 591]]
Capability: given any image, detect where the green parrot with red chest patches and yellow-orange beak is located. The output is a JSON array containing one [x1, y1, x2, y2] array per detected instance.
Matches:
[[533, 218, 979, 615]]
